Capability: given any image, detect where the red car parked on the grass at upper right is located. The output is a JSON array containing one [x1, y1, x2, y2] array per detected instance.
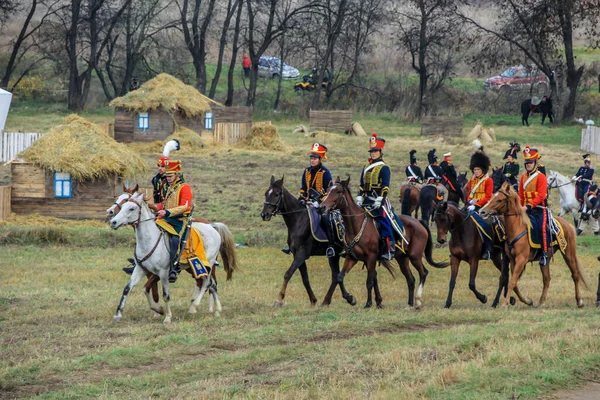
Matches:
[[483, 65, 550, 95]]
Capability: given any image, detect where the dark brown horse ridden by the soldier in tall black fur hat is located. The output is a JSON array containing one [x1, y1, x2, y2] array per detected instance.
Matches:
[[433, 202, 508, 308]]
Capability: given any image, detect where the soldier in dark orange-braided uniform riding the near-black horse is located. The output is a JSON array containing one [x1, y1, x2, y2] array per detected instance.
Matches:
[[281, 143, 335, 257]]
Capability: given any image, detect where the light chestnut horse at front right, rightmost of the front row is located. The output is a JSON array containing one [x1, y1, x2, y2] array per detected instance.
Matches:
[[479, 182, 587, 307]]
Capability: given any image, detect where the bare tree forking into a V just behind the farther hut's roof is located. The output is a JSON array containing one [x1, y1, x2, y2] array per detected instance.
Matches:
[[178, 0, 216, 93]]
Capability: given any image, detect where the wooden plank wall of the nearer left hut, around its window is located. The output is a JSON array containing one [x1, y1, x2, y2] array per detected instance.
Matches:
[[11, 163, 120, 219]]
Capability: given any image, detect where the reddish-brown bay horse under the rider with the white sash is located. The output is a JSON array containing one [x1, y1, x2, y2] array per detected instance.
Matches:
[[321, 177, 450, 308]]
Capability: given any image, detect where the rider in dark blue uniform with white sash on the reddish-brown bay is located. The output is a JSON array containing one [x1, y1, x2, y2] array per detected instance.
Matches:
[[356, 133, 396, 260]]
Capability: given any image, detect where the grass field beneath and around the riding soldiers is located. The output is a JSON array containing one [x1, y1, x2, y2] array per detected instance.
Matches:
[[0, 109, 600, 399]]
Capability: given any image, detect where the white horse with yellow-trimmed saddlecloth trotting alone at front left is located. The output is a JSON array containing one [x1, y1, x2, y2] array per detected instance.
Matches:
[[110, 193, 237, 323]]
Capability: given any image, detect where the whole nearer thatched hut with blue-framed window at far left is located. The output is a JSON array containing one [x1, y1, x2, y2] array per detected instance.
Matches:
[[11, 115, 147, 219]]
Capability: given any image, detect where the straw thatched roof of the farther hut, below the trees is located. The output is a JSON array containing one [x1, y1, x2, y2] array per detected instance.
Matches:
[[110, 74, 222, 118]]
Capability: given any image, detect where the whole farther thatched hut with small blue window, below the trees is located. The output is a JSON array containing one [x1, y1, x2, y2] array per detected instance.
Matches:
[[110, 74, 222, 143]]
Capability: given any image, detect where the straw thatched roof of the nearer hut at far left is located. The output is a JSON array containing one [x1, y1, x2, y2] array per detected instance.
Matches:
[[20, 114, 148, 181]]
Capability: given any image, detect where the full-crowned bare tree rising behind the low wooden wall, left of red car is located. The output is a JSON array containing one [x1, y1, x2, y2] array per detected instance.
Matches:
[[394, 0, 464, 119]]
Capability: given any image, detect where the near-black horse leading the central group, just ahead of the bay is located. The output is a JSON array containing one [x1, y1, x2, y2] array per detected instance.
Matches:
[[260, 176, 356, 307]]
